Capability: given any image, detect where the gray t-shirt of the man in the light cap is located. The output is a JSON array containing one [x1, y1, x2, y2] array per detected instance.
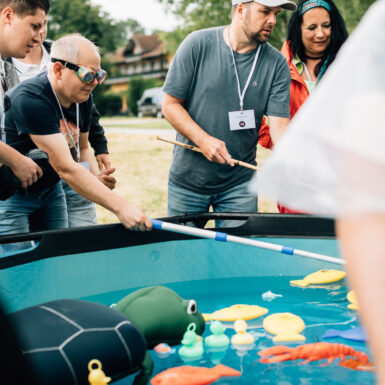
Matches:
[[163, 27, 290, 194]]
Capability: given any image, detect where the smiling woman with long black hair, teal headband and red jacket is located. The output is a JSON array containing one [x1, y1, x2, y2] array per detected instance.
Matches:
[[258, 0, 348, 213]]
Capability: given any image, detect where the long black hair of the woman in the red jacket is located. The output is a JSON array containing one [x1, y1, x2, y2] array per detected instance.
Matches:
[[287, 0, 348, 76]]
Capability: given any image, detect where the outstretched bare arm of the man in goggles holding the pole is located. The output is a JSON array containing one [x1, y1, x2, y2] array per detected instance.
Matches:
[[30, 134, 152, 231]]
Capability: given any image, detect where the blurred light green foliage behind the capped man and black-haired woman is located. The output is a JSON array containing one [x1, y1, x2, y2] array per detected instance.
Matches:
[[159, 0, 375, 54]]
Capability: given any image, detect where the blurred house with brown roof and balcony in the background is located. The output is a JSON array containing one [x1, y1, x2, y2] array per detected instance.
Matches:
[[105, 34, 171, 111]]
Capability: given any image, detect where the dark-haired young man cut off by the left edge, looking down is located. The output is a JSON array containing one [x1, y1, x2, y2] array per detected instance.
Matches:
[[0, 0, 50, 199]]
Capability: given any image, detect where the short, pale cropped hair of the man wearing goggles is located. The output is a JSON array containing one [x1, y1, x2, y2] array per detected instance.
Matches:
[[51, 33, 100, 63]]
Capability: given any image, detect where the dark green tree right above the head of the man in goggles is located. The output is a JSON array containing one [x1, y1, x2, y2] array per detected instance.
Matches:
[[48, 0, 117, 53]]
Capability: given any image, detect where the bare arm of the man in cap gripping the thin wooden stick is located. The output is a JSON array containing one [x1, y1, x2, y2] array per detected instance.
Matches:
[[162, 93, 234, 166]]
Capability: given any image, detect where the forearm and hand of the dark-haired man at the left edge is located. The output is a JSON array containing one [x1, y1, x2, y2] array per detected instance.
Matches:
[[0, 141, 43, 188]]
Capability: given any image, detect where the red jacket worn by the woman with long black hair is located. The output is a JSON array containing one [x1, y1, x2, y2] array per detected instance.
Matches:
[[258, 41, 309, 213]]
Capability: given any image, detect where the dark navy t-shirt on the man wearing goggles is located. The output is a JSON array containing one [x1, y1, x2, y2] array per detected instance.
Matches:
[[5, 72, 92, 154]]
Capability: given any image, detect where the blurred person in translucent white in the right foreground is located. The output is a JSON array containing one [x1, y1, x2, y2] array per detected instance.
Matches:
[[252, 0, 385, 385]]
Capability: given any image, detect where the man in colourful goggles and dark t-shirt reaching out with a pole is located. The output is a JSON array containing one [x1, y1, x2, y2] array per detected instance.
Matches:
[[0, 34, 152, 234]]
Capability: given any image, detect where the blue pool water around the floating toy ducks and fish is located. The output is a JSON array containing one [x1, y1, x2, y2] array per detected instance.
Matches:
[[83, 276, 375, 385]]
